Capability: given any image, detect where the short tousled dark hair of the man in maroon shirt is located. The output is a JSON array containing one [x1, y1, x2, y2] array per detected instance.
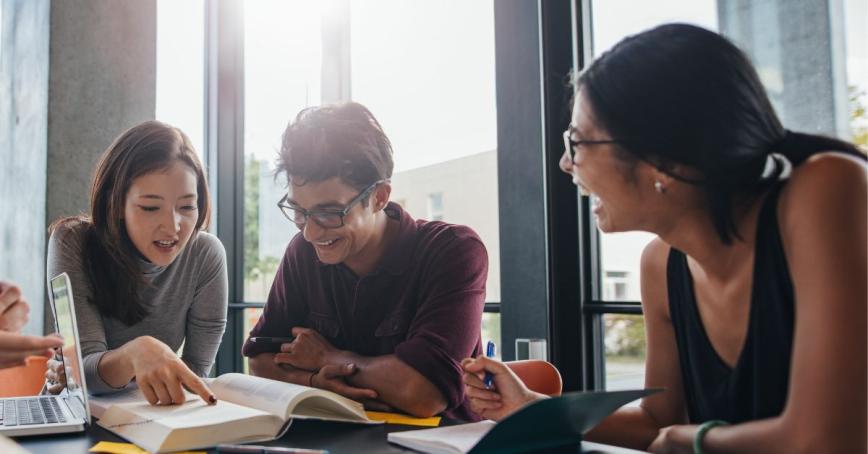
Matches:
[[277, 102, 394, 197]]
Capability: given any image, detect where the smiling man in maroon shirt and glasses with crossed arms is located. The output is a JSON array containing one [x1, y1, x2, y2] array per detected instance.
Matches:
[[243, 103, 488, 420]]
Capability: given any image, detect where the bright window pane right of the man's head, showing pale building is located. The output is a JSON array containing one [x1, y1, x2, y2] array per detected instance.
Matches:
[[349, 0, 500, 301]]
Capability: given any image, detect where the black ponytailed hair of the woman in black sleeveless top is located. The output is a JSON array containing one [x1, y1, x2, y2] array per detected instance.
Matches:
[[576, 24, 864, 243]]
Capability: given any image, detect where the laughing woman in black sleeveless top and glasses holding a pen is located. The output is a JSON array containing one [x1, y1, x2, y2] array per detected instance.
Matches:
[[463, 24, 868, 453]]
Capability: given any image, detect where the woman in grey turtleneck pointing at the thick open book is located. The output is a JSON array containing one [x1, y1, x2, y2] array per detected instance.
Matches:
[[48, 121, 228, 405]]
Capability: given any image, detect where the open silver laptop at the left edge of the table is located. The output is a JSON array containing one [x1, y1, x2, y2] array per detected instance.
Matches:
[[0, 273, 90, 437]]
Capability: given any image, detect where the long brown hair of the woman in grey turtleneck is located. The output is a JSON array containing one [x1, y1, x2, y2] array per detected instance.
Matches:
[[49, 121, 211, 325]]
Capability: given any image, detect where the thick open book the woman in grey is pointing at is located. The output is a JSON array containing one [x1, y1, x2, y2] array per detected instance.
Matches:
[[90, 374, 381, 453]]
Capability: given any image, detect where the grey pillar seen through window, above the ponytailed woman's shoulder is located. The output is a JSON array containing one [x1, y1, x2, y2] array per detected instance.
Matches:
[[717, 0, 850, 139]]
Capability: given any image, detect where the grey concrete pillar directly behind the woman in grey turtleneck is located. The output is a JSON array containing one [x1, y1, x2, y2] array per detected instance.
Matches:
[[46, 0, 158, 229]]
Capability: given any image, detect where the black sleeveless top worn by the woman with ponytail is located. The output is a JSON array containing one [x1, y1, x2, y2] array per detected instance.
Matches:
[[666, 185, 795, 423]]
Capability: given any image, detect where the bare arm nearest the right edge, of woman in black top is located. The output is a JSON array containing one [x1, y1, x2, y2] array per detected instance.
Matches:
[[651, 155, 868, 453]]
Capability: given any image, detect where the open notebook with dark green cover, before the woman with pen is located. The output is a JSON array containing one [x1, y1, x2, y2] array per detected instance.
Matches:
[[388, 389, 661, 454]]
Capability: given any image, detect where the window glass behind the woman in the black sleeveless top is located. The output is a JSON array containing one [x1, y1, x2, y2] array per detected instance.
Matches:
[[590, 0, 868, 389]]
